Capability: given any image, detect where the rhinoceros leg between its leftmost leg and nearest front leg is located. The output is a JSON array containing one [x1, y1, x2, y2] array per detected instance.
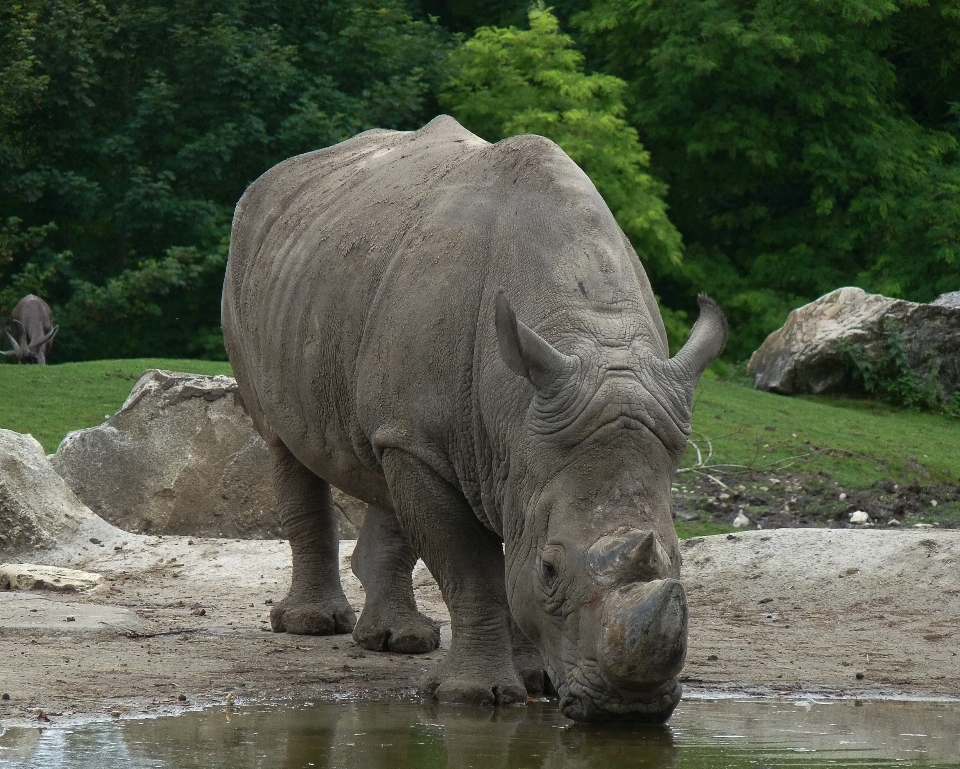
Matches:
[[351, 505, 440, 654]]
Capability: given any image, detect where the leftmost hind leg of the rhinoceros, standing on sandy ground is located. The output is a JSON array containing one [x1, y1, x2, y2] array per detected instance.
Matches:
[[270, 442, 357, 635]]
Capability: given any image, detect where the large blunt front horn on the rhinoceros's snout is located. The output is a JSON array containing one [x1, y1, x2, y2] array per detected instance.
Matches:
[[597, 579, 687, 689]]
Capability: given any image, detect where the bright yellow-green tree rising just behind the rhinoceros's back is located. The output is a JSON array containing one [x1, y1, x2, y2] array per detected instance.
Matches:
[[440, 8, 683, 348]]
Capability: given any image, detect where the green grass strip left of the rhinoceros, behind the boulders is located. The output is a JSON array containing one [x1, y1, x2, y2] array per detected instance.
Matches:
[[0, 358, 232, 454]]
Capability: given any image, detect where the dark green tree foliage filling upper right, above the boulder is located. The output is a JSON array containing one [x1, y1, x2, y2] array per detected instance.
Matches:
[[575, 0, 960, 357]]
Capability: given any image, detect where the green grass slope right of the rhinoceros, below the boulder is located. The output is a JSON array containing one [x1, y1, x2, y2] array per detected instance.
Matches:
[[684, 379, 960, 488]]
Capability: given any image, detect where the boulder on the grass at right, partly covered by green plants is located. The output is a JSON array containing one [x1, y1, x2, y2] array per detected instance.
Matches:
[[747, 287, 960, 396]]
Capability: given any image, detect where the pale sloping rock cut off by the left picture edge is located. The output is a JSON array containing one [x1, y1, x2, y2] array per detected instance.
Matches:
[[0, 430, 119, 561]]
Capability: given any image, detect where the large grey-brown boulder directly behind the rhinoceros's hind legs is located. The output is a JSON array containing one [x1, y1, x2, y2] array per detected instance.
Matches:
[[52, 369, 363, 539]]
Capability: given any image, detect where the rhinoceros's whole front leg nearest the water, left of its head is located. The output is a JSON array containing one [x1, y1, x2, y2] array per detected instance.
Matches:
[[383, 449, 526, 705]]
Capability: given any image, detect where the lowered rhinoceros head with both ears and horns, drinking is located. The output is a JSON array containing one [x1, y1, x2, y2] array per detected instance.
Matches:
[[496, 294, 727, 721]]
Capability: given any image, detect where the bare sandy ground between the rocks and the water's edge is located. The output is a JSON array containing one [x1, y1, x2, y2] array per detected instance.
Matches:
[[0, 529, 960, 729]]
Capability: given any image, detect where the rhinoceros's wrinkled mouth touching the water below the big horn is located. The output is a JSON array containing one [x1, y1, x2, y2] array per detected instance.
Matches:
[[560, 678, 683, 723]]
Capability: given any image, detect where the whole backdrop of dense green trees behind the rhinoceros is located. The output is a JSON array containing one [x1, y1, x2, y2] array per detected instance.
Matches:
[[0, 0, 960, 361]]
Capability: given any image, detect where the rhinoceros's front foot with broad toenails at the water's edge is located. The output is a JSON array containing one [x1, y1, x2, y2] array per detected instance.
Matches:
[[420, 650, 527, 705]]
